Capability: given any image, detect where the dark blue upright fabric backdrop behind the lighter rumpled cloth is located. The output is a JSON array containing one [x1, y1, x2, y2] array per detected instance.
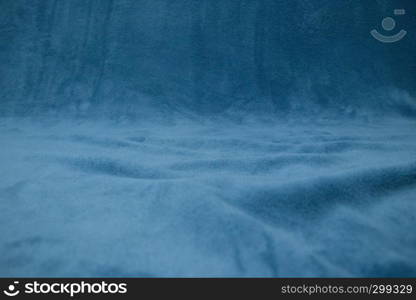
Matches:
[[0, 0, 416, 117]]
